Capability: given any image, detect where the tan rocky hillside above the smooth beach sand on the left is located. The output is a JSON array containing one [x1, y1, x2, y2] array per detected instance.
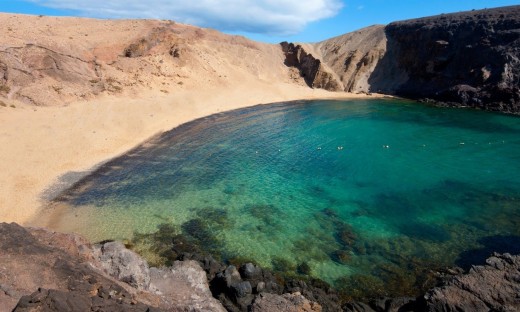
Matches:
[[0, 14, 304, 106]]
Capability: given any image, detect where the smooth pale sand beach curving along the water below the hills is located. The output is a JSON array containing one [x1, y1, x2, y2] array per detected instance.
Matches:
[[0, 82, 388, 226]]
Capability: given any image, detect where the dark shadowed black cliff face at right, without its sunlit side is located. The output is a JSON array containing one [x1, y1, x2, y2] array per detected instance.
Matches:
[[369, 6, 520, 113]]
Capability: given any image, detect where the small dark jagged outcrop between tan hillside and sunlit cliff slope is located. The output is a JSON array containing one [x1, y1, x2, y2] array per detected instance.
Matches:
[[280, 42, 343, 91]]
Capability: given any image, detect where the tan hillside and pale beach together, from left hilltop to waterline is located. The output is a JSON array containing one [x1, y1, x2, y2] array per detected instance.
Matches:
[[0, 14, 382, 223]]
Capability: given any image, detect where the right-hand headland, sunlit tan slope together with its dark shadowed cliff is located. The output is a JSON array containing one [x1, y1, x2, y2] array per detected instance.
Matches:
[[309, 6, 520, 113]]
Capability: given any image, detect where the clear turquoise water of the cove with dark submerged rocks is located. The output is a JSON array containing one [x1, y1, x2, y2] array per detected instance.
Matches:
[[42, 100, 520, 296]]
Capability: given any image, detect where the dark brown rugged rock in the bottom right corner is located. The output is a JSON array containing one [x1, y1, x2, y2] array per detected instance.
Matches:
[[345, 254, 520, 312]]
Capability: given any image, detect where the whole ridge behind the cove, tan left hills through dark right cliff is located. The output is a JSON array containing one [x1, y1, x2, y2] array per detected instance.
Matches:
[[0, 6, 520, 113]]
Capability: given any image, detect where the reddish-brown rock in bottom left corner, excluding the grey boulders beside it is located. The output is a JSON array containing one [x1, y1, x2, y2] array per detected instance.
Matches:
[[0, 223, 161, 311]]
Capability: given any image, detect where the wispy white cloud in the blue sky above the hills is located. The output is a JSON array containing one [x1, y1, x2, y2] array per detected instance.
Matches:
[[29, 0, 343, 35]]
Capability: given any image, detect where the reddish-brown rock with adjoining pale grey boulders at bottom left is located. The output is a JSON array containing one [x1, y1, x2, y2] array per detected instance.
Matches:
[[0, 223, 229, 312]]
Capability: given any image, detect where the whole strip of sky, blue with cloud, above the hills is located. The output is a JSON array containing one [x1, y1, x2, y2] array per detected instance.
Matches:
[[0, 0, 520, 43]]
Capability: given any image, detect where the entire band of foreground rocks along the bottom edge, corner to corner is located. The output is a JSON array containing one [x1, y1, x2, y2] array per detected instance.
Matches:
[[0, 223, 520, 312]]
